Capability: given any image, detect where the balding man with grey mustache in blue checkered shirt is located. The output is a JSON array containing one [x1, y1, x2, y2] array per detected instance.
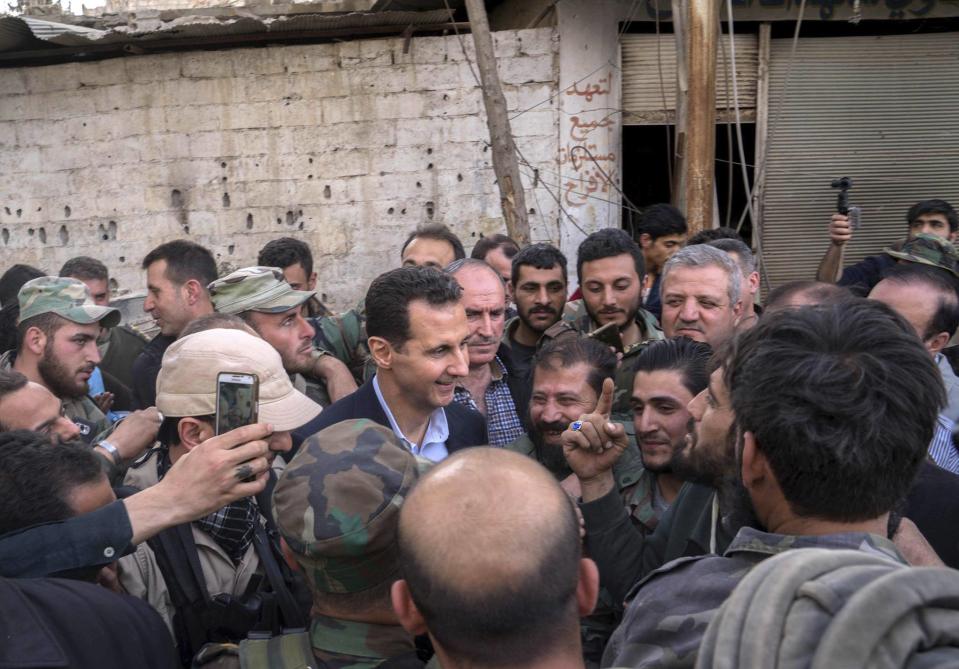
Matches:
[[446, 258, 524, 446]]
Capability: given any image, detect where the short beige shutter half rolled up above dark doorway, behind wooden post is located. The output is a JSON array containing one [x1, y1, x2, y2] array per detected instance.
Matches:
[[622, 34, 759, 125]]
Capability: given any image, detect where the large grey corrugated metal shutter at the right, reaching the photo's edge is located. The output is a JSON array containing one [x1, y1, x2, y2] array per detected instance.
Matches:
[[762, 33, 959, 287]]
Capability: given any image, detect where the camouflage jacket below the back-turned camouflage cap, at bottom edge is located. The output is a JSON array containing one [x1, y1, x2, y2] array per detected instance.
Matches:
[[310, 613, 424, 669]]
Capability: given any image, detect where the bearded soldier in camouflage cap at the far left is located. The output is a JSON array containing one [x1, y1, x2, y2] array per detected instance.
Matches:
[[0, 276, 120, 443]]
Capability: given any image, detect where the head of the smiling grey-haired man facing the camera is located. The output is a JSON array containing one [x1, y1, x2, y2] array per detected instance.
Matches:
[[662, 244, 743, 350]]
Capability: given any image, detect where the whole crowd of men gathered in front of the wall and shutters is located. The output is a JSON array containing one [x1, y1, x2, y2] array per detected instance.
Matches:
[[0, 200, 959, 669]]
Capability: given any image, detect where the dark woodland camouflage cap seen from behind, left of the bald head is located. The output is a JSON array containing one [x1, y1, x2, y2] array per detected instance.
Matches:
[[273, 419, 420, 593]]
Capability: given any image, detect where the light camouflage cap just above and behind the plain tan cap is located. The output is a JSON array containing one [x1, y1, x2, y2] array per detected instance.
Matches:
[[207, 267, 316, 314]]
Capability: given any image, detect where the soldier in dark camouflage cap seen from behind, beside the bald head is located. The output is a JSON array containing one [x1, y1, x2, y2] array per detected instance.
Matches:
[[273, 419, 423, 669]]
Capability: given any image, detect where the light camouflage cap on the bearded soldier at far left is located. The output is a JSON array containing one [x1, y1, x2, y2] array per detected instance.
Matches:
[[17, 276, 120, 328]]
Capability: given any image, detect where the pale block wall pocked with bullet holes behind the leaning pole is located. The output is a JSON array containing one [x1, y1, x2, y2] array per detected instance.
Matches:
[[0, 28, 561, 308]]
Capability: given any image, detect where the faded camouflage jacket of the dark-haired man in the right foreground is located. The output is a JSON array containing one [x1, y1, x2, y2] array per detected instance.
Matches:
[[603, 527, 905, 669]]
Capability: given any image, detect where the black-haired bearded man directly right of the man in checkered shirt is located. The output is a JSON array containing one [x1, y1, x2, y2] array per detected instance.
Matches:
[[503, 243, 571, 379]]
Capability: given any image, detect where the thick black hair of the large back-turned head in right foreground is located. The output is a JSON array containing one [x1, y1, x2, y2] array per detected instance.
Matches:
[[723, 298, 946, 522]]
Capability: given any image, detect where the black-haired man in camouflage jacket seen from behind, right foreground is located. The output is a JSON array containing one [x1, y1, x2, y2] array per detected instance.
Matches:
[[603, 300, 945, 668]]
